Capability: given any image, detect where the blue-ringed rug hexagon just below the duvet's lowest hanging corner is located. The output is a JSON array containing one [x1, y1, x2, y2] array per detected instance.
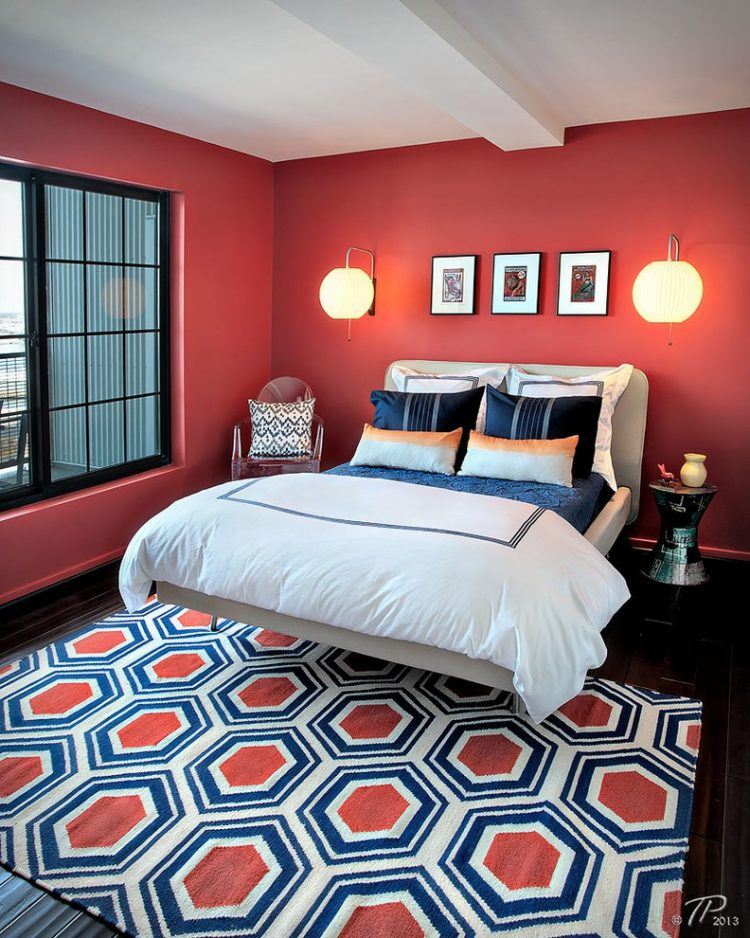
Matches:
[[427, 717, 555, 800]]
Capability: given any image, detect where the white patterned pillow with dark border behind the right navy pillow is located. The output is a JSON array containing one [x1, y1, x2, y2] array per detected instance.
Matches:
[[507, 365, 633, 490]]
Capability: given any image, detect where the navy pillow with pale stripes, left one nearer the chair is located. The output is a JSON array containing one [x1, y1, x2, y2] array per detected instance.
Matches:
[[370, 388, 484, 436]]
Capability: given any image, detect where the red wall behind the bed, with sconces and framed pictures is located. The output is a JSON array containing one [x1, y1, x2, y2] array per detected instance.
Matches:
[[272, 110, 750, 559]]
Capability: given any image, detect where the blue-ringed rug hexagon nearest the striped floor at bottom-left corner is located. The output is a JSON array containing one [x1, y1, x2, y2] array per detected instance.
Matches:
[[27, 772, 183, 880]]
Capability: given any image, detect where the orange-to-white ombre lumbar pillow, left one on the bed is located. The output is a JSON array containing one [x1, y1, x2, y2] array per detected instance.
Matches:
[[350, 423, 463, 475]]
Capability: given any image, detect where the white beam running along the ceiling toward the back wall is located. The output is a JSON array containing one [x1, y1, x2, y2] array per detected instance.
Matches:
[[274, 0, 564, 150]]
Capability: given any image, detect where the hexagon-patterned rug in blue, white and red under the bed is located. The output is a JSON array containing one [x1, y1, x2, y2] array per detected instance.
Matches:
[[0, 602, 701, 938]]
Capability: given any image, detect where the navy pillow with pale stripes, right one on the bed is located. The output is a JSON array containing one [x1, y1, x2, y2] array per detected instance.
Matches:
[[484, 386, 602, 479]]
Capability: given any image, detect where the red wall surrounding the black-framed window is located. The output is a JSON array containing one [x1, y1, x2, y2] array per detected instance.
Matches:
[[0, 84, 273, 603]]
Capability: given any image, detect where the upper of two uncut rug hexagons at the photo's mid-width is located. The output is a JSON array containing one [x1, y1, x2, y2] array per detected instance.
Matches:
[[310, 689, 430, 756]]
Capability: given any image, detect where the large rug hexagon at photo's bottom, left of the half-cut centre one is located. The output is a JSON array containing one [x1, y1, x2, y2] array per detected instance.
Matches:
[[141, 817, 310, 938]]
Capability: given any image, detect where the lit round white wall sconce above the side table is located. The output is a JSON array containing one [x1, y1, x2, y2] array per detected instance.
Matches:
[[633, 234, 703, 345]]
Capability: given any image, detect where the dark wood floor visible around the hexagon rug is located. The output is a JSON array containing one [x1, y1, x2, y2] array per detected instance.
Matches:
[[0, 551, 750, 938]]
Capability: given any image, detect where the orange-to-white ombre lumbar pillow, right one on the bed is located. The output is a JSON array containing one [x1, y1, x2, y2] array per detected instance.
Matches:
[[459, 430, 578, 488]]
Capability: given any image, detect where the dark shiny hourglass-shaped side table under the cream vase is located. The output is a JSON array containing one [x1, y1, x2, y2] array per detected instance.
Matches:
[[643, 482, 717, 586]]
